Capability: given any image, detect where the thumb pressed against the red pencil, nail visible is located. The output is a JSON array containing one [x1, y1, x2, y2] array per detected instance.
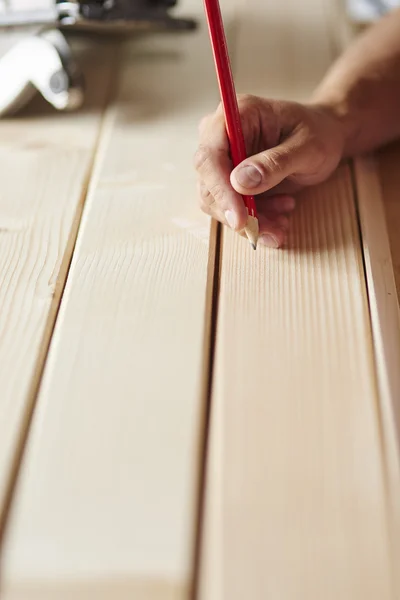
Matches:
[[231, 138, 310, 195]]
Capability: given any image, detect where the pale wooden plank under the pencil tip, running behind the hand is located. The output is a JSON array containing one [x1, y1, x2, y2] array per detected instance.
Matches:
[[201, 0, 398, 600]]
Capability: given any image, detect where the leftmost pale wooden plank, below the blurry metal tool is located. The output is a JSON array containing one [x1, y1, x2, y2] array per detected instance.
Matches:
[[0, 32, 111, 530]]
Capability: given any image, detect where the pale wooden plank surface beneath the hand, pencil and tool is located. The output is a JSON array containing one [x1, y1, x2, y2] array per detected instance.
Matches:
[[0, 0, 400, 600]]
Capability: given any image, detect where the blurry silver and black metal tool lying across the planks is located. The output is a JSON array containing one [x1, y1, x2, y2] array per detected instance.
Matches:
[[0, 0, 196, 117]]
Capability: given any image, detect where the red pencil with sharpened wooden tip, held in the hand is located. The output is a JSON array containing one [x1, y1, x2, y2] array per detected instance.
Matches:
[[204, 0, 258, 250]]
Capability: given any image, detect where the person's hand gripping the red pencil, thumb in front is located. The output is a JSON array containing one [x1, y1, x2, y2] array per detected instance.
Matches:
[[195, 96, 345, 248]]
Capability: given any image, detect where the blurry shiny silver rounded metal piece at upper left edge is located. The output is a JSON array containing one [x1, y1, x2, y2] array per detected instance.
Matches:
[[0, 29, 83, 116]]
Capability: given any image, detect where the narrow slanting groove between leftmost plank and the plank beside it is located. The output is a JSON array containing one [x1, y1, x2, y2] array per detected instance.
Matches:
[[0, 44, 118, 556]]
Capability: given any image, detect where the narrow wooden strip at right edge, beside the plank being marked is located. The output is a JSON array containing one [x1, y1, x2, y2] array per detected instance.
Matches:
[[355, 156, 400, 598]]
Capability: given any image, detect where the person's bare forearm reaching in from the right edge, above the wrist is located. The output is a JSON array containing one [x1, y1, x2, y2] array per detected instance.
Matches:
[[312, 11, 400, 156]]
